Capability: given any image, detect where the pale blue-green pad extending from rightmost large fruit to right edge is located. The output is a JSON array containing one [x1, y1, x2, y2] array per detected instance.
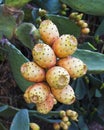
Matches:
[[73, 49, 104, 73]]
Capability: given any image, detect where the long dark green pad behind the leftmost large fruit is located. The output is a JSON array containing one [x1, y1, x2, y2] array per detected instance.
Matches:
[[5, 43, 33, 92]]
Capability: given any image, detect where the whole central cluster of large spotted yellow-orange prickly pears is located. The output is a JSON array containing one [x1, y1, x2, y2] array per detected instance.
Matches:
[[21, 20, 87, 114]]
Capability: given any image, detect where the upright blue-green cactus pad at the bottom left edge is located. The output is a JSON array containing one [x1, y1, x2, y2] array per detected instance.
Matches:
[[10, 109, 30, 130]]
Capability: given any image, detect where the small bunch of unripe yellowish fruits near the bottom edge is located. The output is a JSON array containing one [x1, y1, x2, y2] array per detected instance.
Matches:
[[53, 109, 78, 130]]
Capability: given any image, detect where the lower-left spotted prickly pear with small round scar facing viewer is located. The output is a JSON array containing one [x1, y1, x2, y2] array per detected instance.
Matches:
[[24, 82, 50, 103]]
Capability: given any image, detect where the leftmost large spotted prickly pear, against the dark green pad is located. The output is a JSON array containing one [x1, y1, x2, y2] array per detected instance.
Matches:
[[20, 62, 45, 82]]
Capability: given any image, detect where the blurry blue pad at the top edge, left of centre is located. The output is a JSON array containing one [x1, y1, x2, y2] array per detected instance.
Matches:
[[34, 0, 61, 14]]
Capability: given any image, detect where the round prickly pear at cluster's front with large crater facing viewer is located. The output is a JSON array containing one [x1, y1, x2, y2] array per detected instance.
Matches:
[[46, 66, 70, 89]]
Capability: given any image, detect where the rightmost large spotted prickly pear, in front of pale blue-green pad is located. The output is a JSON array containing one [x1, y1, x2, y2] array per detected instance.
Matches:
[[57, 56, 87, 79]]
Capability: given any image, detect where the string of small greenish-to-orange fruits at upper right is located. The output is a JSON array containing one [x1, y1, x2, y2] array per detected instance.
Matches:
[[69, 12, 90, 34]]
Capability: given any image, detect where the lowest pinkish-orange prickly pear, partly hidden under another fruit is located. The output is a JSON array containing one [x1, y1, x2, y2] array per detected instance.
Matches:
[[36, 93, 55, 114]]
